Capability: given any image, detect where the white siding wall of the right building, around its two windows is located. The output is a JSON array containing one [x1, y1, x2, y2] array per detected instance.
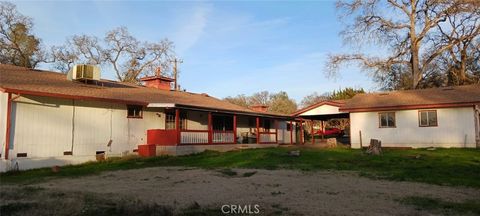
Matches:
[[350, 107, 475, 148]]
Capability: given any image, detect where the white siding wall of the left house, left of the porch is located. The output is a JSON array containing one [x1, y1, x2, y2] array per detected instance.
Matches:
[[8, 95, 165, 158]]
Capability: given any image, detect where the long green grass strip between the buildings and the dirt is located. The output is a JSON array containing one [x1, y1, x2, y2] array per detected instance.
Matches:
[[0, 148, 480, 188]]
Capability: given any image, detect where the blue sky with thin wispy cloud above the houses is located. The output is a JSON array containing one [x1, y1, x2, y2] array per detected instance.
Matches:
[[14, 1, 376, 102]]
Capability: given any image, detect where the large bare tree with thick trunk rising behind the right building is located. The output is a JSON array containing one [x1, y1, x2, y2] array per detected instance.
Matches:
[[327, 0, 475, 88]]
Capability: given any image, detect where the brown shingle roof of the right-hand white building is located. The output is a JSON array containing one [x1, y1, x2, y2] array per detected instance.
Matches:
[[341, 84, 480, 112]]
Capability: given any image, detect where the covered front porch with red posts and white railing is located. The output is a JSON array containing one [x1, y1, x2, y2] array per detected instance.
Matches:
[[139, 107, 290, 156]]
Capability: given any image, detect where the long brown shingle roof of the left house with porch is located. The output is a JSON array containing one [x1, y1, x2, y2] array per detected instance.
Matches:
[[0, 64, 282, 116]]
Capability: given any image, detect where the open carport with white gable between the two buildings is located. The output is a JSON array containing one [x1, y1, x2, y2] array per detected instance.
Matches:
[[292, 100, 350, 144]]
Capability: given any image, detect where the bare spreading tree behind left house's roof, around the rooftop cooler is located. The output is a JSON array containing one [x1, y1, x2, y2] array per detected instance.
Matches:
[[52, 27, 174, 83]]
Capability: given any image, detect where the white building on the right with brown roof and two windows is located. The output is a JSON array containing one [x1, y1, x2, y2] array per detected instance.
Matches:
[[293, 84, 480, 148]]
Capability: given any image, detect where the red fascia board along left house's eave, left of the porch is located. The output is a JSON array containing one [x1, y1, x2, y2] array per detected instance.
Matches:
[[4, 88, 148, 106]]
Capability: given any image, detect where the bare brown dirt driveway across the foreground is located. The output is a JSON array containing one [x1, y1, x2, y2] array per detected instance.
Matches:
[[2, 167, 468, 215]]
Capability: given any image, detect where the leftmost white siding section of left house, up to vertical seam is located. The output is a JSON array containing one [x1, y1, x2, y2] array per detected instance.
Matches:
[[9, 97, 73, 158]]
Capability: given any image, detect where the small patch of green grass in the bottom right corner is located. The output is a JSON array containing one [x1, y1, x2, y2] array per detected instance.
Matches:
[[400, 196, 480, 215]]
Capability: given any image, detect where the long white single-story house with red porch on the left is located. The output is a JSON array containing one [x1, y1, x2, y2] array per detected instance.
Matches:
[[0, 64, 295, 171]]
